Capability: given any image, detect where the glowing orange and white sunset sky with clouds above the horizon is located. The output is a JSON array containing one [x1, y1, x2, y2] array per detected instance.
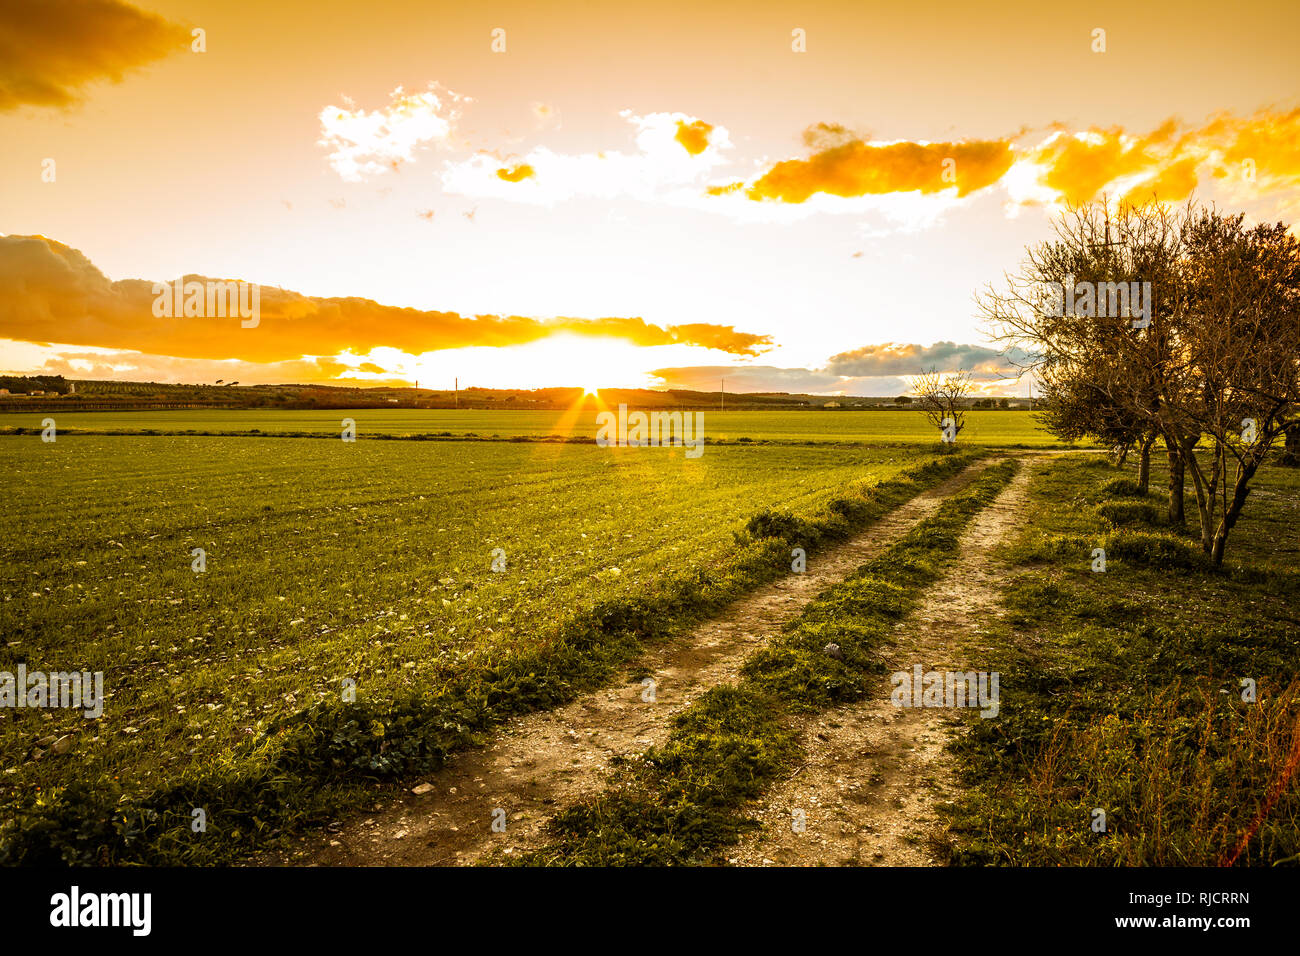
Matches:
[[0, 0, 1300, 394]]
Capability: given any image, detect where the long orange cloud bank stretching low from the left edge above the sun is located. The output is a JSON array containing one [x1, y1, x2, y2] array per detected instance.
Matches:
[[0, 235, 771, 363]]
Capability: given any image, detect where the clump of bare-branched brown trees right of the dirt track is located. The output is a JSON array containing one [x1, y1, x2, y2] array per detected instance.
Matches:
[[979, 202, 1300, 564]]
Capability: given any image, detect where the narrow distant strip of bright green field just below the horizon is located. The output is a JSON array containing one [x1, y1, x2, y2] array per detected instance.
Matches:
[[0, 405, 1061, 446]]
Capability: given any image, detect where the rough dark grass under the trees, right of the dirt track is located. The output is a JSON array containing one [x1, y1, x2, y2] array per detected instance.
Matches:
[[945, 458, 1300, 866]]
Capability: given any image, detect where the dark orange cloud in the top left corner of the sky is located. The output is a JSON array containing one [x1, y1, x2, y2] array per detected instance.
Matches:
[[0, 0, 190, 112]]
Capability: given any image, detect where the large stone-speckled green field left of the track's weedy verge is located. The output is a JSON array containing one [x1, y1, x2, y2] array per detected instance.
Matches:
[[0, 436, 956, 868]]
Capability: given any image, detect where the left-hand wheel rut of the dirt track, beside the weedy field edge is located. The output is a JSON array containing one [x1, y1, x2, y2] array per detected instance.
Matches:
[[273, 463, 985, 866]]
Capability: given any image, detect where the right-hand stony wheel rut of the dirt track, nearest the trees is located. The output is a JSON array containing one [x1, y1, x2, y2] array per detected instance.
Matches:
[[728, 460, 1032, 866]]
